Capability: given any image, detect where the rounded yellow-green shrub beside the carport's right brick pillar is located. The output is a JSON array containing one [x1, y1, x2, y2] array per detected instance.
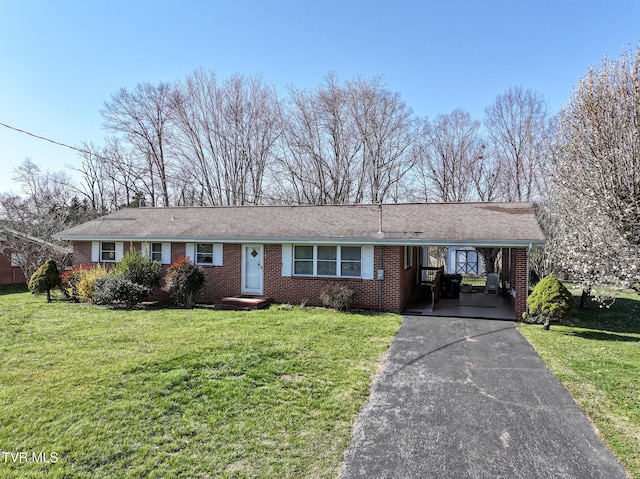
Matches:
[[529, 274, 573, 329]]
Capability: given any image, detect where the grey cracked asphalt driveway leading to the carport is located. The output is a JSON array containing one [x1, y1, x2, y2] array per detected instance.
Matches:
[[340, 316, 627, 479]]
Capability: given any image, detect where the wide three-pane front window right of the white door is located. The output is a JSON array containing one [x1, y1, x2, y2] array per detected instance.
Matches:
[[293, 245, 362, 278]]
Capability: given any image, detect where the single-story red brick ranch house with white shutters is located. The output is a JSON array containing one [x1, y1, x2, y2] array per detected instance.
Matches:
[[57, 203, 544, 318]]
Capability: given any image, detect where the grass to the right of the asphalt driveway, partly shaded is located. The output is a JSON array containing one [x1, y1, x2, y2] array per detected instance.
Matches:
[[520, 286, 640, 478]]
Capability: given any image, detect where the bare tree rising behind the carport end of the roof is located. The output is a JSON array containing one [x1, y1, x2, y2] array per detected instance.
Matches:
[[484, 87, 549, 201]]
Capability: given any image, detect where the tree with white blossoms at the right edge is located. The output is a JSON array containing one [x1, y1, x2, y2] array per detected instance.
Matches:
[[551, 46, 640, 300]]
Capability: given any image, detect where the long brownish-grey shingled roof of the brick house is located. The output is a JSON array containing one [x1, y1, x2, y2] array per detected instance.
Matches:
[[56, 203, 545, 246]]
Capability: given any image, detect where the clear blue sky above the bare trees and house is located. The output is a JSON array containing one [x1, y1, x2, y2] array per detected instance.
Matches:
[[0, 0, 640, 192]]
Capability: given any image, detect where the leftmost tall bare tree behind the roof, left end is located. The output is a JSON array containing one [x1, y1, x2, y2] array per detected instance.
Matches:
[[102, 83, 172, 206]]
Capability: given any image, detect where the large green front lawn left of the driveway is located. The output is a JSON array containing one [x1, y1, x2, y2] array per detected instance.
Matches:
[[0, 289, 401, 478]]
